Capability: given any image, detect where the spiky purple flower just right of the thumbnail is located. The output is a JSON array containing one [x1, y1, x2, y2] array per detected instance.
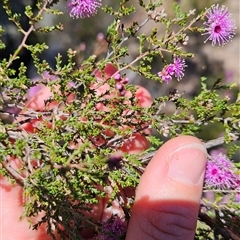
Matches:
[[205, 153, 239, 189]]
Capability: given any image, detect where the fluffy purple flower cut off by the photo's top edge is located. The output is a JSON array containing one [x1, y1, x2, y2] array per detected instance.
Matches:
[[68, 0, 102, 18]]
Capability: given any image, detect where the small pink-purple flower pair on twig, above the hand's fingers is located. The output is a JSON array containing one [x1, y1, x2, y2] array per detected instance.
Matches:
[[158, 57, 187, 83]]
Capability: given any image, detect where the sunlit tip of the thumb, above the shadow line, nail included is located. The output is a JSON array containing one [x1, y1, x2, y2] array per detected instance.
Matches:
[[136, 136, 207, 202]]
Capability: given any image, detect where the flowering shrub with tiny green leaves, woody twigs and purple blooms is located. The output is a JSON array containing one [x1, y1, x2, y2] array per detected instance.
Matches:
[[0, 0, 240, 239]]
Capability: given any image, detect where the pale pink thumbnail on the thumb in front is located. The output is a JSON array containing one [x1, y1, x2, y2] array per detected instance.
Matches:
[[169, 143, 207, 185]]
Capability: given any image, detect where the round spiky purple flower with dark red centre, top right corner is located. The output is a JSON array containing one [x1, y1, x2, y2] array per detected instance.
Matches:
[[203, 5, 236, 46]]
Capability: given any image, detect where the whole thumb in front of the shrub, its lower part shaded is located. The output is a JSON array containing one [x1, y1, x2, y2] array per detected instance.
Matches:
[[126, 136, 207, 240]]
